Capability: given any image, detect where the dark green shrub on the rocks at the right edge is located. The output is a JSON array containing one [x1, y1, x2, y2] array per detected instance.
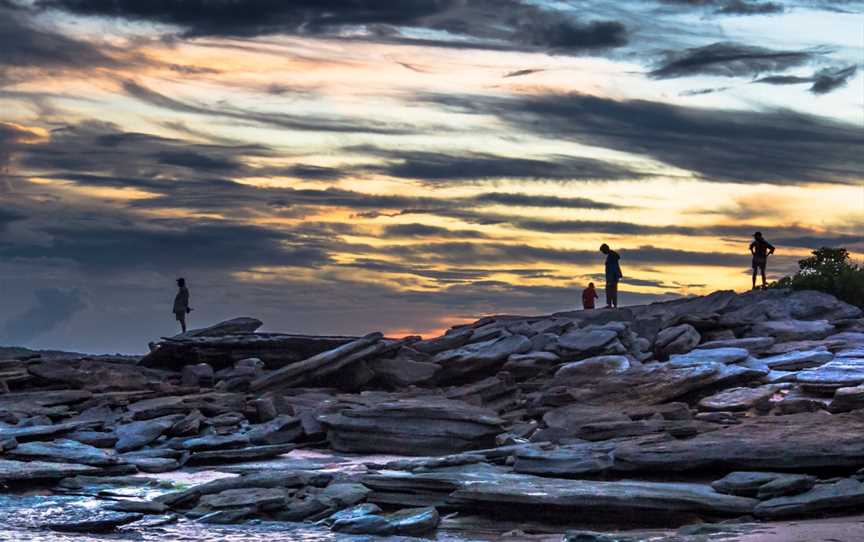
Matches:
[[771, 247, 864, 308]]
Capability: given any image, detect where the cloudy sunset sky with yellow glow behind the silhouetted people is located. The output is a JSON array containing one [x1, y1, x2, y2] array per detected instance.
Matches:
[[0, 0, 864, 353]]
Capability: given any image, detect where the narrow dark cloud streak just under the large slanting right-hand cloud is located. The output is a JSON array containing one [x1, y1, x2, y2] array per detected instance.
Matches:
[[354, 147, 643, 184]]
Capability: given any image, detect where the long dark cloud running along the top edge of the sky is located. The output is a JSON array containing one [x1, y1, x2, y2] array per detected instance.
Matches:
[[37, 0, 627, 53]]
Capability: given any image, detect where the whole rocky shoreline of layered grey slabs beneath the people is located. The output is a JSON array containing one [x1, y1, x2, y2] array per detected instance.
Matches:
[[0, 290, 864, 541]]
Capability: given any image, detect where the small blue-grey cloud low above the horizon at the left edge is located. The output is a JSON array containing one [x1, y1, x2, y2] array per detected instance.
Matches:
[[3, 288, 87, 344]]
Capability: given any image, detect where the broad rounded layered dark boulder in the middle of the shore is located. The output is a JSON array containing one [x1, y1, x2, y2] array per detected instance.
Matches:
[[320, 397, 504, 455]]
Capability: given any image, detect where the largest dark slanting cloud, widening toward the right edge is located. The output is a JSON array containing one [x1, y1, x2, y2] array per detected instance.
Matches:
[[421, 94, 864, 185]]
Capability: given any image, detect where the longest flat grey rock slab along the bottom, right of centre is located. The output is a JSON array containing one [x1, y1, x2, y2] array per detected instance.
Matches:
[[449, 475, 757, 516]]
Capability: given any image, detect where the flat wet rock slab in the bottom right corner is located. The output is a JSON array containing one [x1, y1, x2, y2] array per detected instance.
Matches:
[[754, 479, 864, 520]]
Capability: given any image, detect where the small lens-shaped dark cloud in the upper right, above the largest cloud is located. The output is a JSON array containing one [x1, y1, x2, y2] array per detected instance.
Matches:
[[650, 42, 817, 79]]
